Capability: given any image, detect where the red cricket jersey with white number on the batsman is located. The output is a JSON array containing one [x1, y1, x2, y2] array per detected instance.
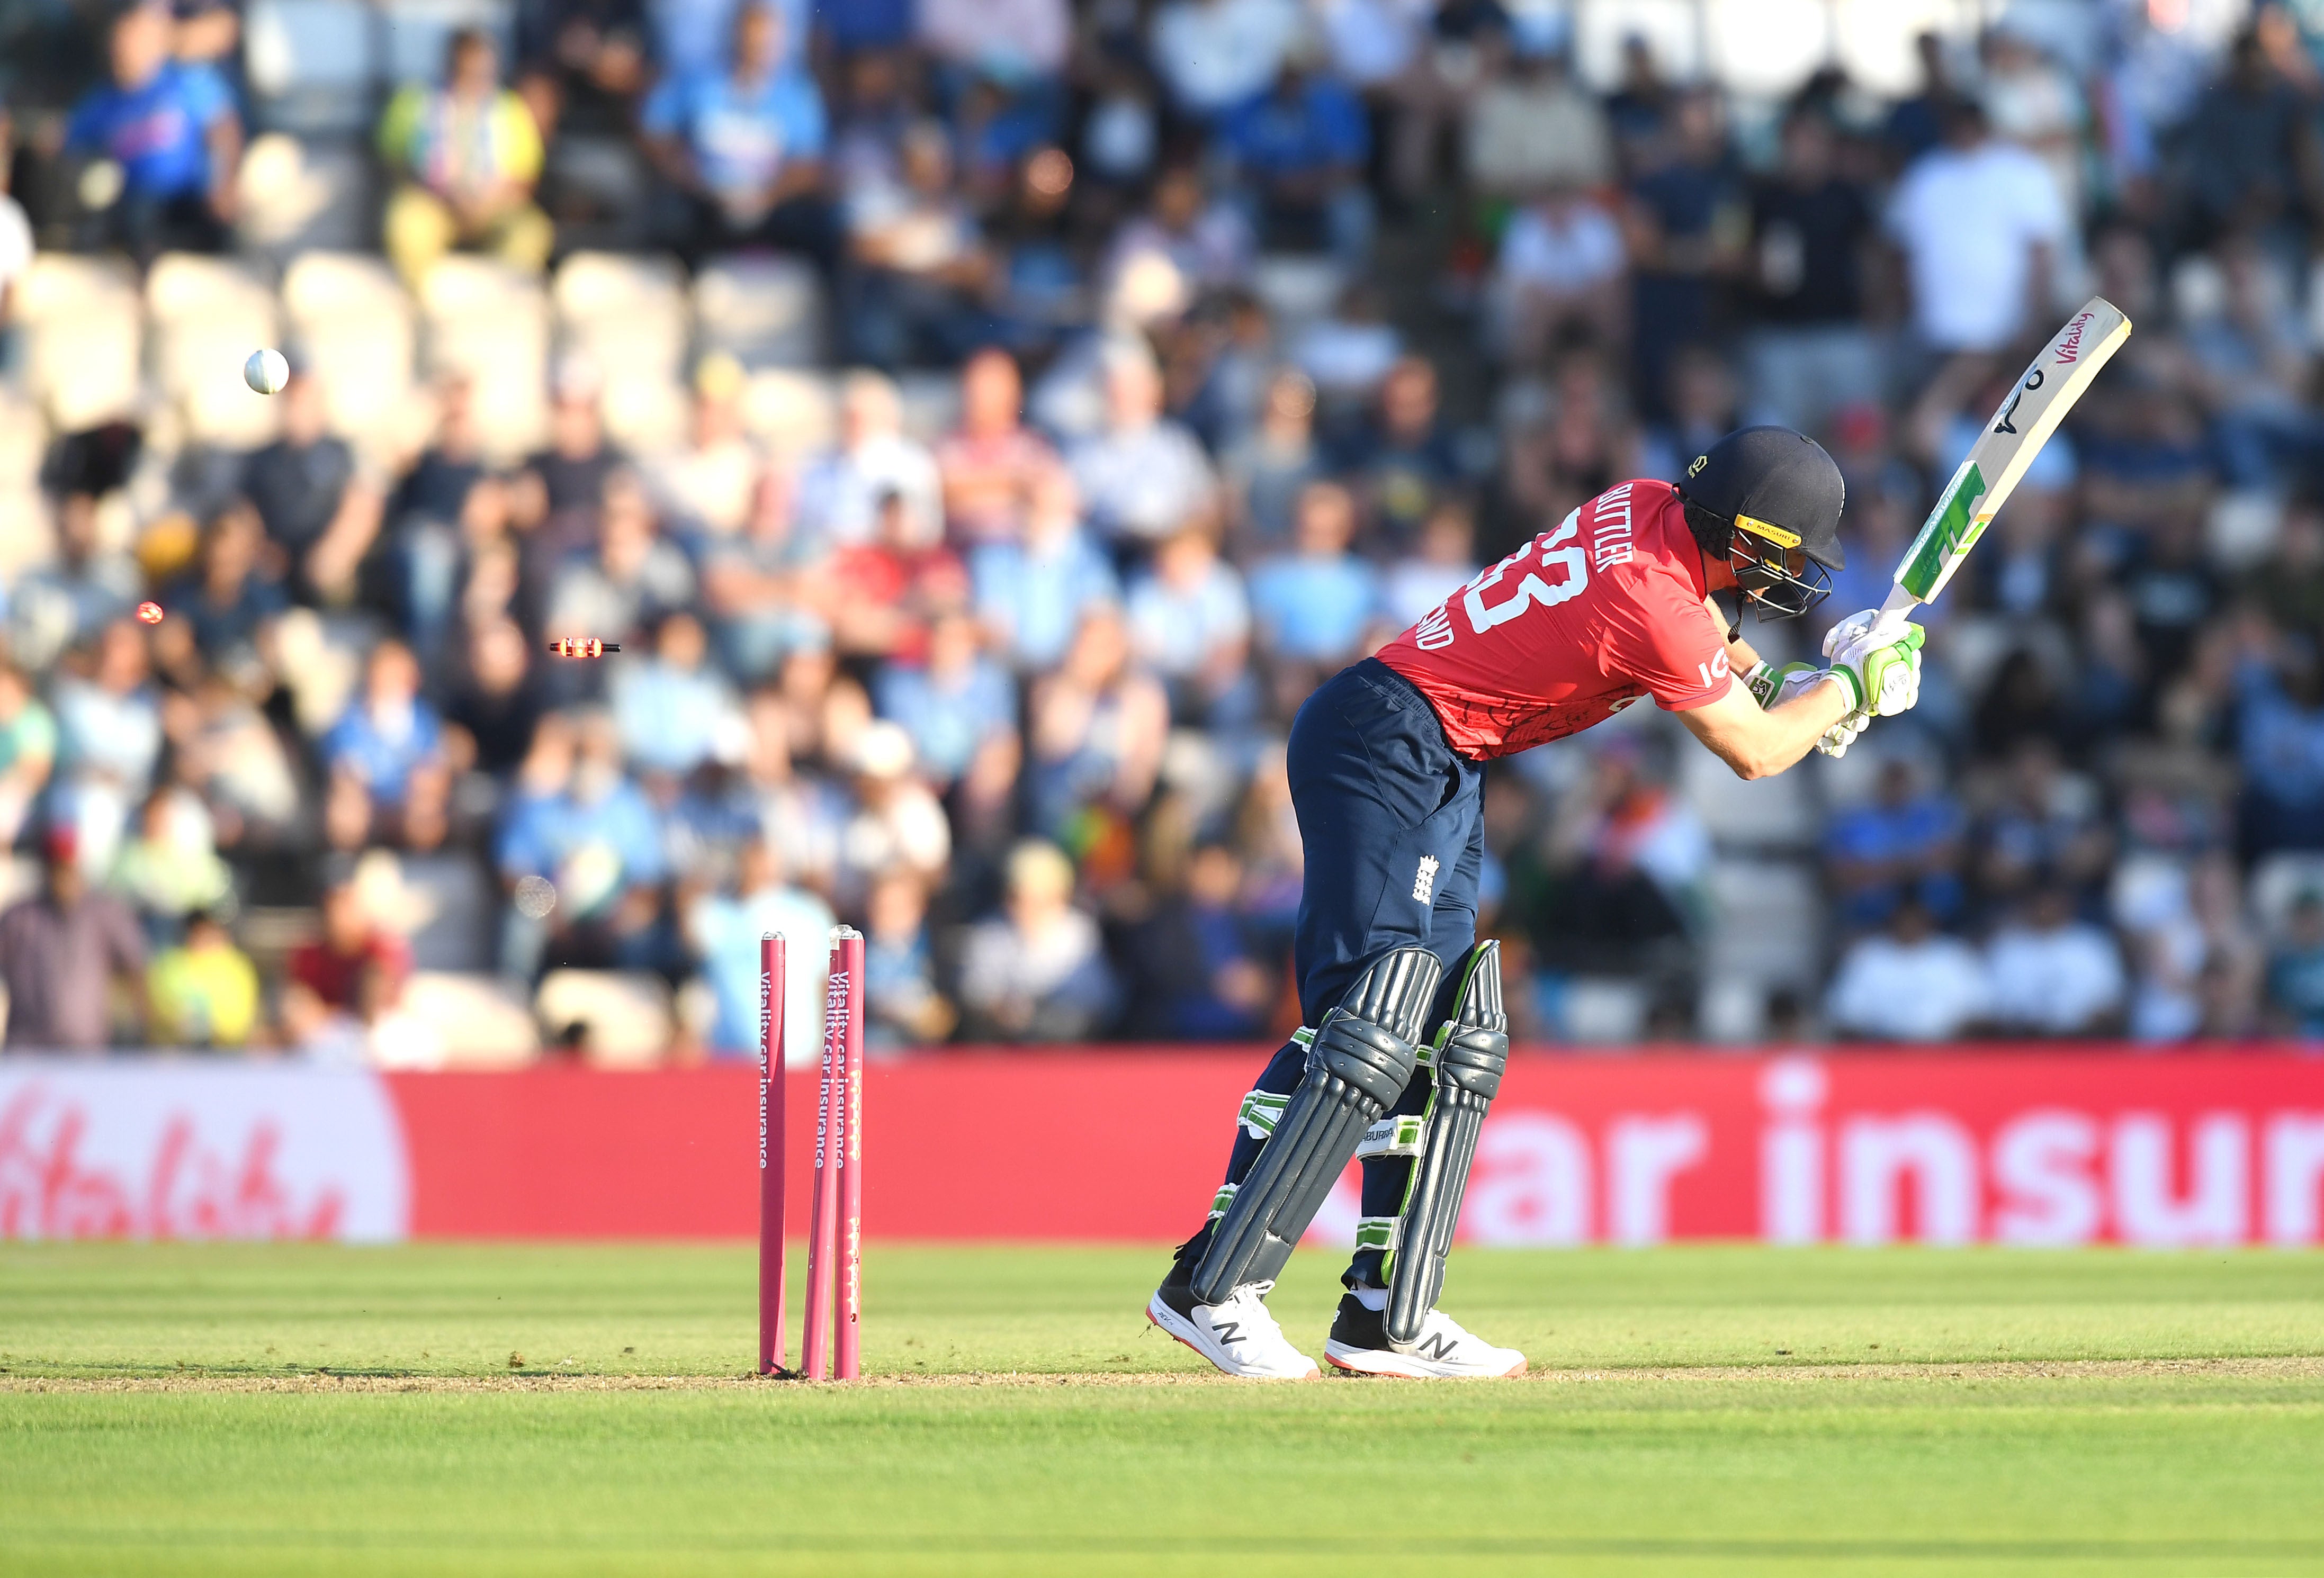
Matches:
[[1378, 481, 1734, 762]]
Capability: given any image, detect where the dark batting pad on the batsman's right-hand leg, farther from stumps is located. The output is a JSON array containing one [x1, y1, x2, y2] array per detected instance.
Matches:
[[1360, 939, 1508, 1346]]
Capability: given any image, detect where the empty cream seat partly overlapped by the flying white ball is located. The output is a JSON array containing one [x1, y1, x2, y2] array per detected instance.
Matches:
[[147, 254, 279, 448]]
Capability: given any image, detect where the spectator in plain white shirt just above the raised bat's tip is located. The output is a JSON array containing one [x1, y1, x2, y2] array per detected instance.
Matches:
[[1887, 100, 2068, 353]]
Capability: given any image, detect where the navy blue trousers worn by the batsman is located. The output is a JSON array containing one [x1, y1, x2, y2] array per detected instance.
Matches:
[[1178, 657, 1485, 1287]]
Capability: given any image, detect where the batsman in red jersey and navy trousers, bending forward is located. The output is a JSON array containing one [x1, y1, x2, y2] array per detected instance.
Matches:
[[1146, 428, 1922, 1381]]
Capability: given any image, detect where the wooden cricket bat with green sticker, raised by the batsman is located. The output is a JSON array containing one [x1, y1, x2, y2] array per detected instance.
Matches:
[[1878, 295, 2131, 627]]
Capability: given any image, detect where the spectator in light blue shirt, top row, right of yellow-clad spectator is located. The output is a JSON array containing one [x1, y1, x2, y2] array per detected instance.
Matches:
[[641, 2, 839, 272]]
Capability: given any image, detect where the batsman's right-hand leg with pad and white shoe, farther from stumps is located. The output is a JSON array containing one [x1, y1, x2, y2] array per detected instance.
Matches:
[[1325, 820, 1524, 1381]]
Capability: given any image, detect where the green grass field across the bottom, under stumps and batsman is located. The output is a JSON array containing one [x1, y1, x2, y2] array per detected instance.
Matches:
[[0, 1246, 2324, 1578]]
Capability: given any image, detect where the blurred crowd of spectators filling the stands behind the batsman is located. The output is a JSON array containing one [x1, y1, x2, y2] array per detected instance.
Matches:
[[0, 0, 2324, 1065]]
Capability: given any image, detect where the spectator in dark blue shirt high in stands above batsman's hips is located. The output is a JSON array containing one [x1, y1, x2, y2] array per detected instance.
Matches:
[[1220, 63, 1371, 265]]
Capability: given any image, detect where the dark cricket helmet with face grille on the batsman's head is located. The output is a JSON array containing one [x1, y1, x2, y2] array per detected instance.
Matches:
[[1678, 428, 1847, 620]]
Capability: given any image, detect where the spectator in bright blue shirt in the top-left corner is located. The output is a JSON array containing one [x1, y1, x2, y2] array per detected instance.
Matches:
[[65, 5, 241, 265]]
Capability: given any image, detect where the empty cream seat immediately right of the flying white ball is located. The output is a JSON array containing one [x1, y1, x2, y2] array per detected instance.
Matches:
[[281, 251, 425, 446]]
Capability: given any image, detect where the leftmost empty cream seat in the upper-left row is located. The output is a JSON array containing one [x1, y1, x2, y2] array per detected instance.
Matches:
[[14, 251, 144, 432]]
